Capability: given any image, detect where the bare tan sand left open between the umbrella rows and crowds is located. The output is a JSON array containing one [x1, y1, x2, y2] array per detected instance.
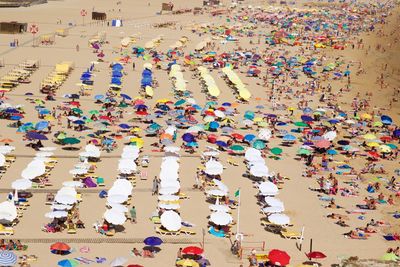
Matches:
[[0, 0, 400, 266]]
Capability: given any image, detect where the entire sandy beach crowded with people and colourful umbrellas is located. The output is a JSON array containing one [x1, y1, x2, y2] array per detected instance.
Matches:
[[0, 0, 400, 266]]
